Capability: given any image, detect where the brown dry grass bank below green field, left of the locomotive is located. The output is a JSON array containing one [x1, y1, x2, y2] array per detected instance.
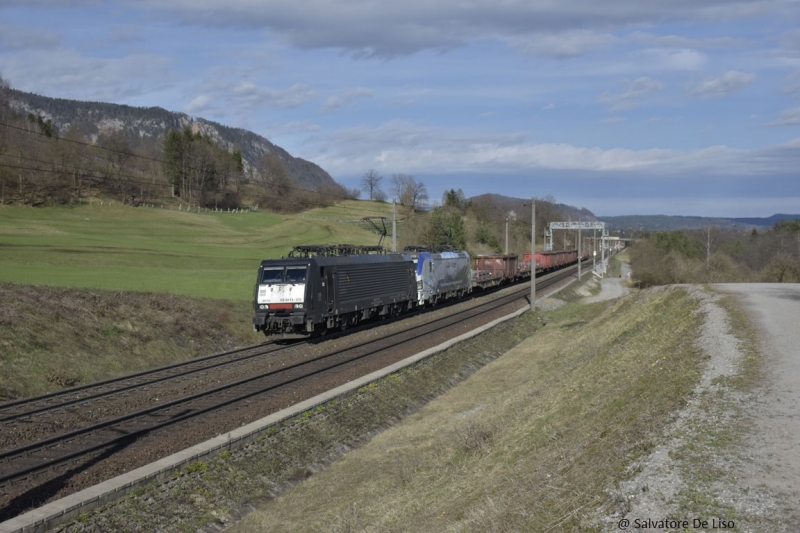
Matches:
[[0, 284, 263, 402]]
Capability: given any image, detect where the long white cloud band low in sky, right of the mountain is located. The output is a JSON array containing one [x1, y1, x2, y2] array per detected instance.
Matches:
[[296, 121, 800, 177]]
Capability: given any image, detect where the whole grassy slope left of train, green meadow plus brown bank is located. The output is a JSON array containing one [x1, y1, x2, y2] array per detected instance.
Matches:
[[0, 202, 391, 401]]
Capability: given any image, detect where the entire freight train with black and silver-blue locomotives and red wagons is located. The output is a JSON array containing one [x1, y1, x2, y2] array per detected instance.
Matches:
[[253, 245, 578, 338]]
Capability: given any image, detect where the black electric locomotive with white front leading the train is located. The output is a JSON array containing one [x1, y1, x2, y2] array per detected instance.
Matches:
[[253, 254, 417, 338]]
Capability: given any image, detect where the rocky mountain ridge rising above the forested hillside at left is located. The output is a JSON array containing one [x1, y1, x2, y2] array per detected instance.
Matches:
[[10, 90, 338, 189]]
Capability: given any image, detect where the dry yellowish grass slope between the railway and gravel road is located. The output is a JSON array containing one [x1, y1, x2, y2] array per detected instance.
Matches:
[[232, 290, 700, 533]]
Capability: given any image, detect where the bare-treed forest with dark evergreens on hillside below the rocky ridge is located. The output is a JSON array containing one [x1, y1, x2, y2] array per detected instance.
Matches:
[[0, 78, 359, 212]]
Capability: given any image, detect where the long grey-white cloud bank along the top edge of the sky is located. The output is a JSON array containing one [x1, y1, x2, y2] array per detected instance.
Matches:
[[138, 0, 796, 57]]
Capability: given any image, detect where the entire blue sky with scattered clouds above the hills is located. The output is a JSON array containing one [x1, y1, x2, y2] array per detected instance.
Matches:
[[0, 0, 800, 216]]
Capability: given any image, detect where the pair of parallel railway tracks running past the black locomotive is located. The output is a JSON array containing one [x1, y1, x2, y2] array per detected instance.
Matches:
[[0, 269, 573, 516]]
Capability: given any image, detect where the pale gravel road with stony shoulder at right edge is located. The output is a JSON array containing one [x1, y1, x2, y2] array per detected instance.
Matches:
[[601, 284, 800, 533]]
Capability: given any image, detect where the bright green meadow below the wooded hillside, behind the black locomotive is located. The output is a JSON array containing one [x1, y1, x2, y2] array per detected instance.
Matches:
[[0, 201, 391, 300]]
